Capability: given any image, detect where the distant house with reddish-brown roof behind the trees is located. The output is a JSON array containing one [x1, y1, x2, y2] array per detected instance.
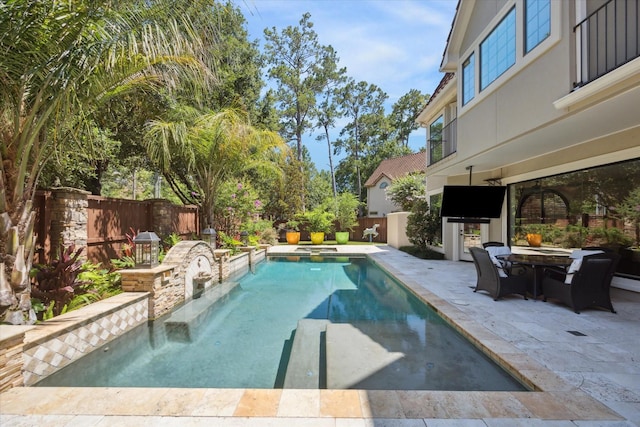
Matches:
[[364, 152, 426, 218]]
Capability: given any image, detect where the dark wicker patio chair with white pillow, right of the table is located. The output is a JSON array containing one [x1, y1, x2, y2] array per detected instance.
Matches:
[[542, 253, 620, 314]]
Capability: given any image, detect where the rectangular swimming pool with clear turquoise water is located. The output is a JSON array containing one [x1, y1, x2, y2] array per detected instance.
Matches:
[[37, 256, 525, 390]]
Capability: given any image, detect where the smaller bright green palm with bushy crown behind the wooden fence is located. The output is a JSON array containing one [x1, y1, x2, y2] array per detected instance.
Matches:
[[145, 108, 288, 226]]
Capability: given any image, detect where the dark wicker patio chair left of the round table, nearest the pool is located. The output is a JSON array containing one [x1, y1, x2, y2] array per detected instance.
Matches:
[[469, 247, 529, 301]]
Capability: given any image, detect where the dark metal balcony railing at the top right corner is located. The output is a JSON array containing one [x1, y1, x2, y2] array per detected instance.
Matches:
[[573, 0, 640, 87]]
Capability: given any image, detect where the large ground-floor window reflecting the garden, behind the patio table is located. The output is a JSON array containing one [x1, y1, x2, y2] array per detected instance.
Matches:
[[508, 159, 640, 278]]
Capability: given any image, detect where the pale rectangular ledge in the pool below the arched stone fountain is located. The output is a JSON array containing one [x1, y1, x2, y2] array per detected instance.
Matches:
[[164, 282, 238, 342]]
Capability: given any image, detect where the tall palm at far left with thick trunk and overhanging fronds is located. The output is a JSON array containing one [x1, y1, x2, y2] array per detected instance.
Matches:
[[0, 0, 210, 324]]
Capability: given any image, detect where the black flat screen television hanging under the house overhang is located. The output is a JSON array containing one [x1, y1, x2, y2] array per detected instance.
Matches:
[[440, 185, 507, 218]]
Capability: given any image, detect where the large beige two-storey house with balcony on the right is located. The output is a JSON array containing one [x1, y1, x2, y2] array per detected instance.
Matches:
[[417, 0, 640, 288]]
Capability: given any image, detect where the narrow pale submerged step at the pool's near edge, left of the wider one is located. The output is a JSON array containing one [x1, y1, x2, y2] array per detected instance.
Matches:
[[284, 319, 331, 389]]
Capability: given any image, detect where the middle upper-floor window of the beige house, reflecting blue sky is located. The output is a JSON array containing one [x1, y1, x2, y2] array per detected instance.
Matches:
[[480, 8, 516, 90]]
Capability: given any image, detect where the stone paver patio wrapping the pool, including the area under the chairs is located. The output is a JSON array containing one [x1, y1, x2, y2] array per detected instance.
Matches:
[[0, 246, 640, 427]]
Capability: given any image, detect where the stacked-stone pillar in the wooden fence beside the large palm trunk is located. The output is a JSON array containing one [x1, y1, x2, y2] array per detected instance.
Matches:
[[49, 187, 91, 259]]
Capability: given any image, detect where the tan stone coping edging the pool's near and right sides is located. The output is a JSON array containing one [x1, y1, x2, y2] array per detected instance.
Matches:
[[0, 246, 624, 421]]
